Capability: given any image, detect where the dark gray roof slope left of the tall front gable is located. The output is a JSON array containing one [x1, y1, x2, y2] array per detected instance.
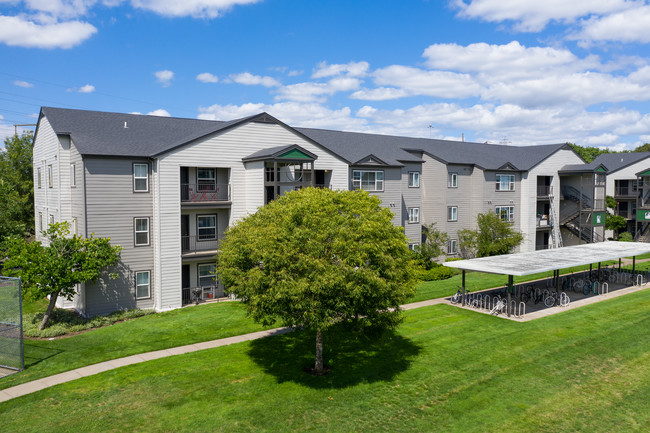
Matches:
[[41, 107, 254, 157]]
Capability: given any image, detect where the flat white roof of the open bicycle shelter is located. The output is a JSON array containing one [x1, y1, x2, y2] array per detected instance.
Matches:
[[444, 241, 650, 276]]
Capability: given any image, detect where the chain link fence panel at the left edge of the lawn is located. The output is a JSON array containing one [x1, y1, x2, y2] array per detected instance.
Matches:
[[0, 277, 25, 377]]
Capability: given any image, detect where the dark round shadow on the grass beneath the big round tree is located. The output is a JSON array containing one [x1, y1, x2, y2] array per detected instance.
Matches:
[[248, 326, 422, 389]]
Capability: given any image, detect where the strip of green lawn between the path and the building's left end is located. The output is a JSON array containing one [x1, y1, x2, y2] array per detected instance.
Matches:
[[0, 302, 264, 390]]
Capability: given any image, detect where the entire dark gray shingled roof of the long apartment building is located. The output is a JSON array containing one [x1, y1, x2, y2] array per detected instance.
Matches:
[[41, 107, 570, 170]]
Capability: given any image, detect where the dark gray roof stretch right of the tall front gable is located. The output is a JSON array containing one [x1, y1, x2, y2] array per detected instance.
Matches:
[[295, 128, 570, 170]]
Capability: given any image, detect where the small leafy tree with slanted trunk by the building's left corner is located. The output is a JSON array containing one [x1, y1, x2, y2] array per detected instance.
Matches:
[[3, 223, 122, 329]]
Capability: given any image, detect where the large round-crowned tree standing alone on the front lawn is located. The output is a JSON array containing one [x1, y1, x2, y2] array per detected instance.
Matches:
[[217, 188, 415, 374]]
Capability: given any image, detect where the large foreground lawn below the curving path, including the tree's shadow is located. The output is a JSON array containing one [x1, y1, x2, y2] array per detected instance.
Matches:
[[0, 290, 650, 432]]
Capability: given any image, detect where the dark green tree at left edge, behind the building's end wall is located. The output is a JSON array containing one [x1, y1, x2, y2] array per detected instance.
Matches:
[[0, 133, 34, 241]]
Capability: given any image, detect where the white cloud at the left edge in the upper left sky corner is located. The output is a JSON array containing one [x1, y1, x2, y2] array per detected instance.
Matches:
[[0, 15, 97, 49]]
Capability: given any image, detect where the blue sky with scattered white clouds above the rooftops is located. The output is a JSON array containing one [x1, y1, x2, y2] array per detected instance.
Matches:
[[0, 0, 650, 150]]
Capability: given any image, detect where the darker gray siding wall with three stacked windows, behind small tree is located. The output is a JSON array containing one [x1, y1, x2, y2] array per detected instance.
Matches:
[[85, 158, 155, 315]]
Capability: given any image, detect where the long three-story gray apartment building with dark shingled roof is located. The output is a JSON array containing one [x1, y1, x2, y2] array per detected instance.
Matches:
[[33, 107, 606, 315]]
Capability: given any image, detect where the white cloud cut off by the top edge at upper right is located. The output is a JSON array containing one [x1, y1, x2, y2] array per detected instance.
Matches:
[[453, 0, 636, 32]]
